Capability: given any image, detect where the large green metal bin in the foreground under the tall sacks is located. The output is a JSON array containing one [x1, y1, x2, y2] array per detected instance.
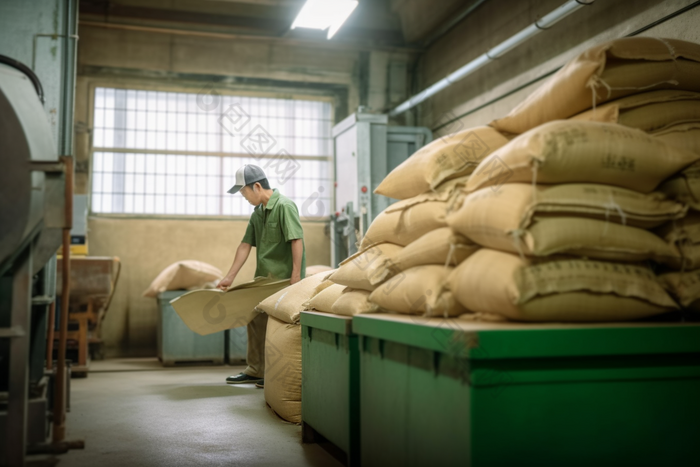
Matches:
[[353, 315, 700, 467]]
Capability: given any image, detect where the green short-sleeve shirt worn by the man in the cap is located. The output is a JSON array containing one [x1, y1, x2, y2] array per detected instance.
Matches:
[[242, 189, 306, 279]]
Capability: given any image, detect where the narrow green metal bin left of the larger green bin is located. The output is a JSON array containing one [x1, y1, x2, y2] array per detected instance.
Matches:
[[301, 311, 360, 466]]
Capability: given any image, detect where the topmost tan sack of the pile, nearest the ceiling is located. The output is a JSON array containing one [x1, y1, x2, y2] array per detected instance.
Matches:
[[490, 37, 700, 134]]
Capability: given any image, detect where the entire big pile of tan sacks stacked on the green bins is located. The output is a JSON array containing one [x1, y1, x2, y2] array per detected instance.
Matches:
[[309, 38, 700, 321]]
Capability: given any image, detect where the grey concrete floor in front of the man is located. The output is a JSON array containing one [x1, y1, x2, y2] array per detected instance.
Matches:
[[53, 359, 342, 467]]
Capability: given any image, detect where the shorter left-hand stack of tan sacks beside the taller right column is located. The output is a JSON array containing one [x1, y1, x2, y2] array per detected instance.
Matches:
[[300, 126, 508, 316]]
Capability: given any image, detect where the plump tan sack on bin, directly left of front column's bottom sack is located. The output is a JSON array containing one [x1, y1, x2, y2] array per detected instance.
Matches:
[[369, 265, 466, 317]]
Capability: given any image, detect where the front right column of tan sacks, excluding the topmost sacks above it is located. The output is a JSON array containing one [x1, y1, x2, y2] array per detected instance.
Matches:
[[448, 120, 700, 321]]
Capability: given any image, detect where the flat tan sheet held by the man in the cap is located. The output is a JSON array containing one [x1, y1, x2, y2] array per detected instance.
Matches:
[[170, 277, 289, 336]]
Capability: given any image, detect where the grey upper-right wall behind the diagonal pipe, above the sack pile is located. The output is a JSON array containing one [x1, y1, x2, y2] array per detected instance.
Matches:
[[401, 0, 700, 134]]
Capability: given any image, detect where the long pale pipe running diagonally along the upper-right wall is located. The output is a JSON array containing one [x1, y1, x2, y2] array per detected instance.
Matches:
[[389, 0, 595, 117]]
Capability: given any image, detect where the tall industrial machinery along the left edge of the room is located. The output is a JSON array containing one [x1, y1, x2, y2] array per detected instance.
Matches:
[[0, 0, 81, 466]]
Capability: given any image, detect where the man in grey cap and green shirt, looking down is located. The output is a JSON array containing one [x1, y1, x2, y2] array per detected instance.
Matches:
[[217, 164, 306, 388]]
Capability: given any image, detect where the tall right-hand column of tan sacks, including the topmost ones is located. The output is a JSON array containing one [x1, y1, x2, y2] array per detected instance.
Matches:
[[448, 38, 700, 321]]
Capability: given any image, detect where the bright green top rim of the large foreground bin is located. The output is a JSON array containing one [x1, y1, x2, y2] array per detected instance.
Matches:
[[352, 315, 700, 360]]
